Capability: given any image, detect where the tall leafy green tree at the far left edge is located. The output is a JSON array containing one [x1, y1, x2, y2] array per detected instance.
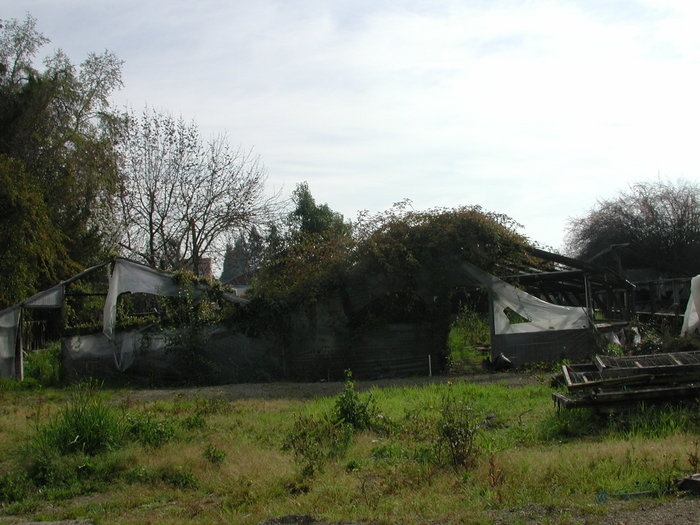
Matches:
[[0, 15, 122, 306]]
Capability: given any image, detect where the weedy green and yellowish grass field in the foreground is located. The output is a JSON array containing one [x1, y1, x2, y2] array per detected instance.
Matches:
[[0, 375, 700, 523]]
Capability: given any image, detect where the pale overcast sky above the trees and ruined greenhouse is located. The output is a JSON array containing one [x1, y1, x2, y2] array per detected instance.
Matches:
[[5, 0, 700, 249]]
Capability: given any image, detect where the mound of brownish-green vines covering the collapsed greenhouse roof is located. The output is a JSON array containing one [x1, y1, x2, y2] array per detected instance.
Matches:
[[253, 193, 537, 317]]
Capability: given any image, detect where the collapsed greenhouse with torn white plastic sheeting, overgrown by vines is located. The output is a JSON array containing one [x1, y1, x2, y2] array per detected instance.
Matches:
[[0, 254, 692, 382]]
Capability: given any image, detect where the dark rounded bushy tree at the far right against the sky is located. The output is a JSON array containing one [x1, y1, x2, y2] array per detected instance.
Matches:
[[567, 180, 700, 277]]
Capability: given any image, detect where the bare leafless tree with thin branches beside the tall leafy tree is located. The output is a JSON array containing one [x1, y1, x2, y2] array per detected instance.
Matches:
[[120, 110, 274, 272]]
